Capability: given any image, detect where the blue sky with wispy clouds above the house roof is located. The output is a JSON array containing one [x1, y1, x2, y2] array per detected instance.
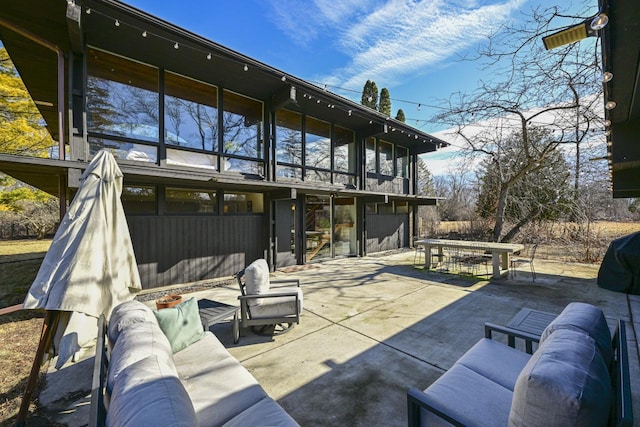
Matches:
[[125, 0, 597, 137]]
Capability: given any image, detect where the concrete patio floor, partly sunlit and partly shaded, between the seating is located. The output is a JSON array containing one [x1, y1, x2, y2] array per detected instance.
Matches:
[[40, 252, 640, 426]]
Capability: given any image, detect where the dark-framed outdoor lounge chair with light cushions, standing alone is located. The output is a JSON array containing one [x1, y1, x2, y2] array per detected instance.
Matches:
[[236, 259, 302, 335]]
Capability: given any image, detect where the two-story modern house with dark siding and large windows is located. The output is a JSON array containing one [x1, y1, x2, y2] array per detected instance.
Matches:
[[0, 0, 446, 288]]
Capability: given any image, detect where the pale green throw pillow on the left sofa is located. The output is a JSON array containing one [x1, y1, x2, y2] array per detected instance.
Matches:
[[153, 298, 204, 353]]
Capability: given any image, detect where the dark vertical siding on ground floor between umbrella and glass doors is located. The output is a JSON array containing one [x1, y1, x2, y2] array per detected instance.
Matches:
[[127, 215, 267, 289]]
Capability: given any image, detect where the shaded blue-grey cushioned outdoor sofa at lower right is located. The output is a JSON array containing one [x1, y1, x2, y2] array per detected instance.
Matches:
[[407, 303, 633, 427]]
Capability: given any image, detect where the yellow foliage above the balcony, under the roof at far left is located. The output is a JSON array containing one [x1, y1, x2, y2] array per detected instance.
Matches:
[[0, 47, 55, 157]]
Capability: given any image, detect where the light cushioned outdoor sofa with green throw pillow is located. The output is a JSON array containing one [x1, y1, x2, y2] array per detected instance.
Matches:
[[89, 299, 298, 427]]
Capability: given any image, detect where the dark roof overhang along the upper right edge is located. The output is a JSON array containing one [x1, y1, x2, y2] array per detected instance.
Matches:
[[600, 0, 640, 197]]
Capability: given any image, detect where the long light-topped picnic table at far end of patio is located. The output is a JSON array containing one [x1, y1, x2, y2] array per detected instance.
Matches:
[[415, 239, 524, 279]]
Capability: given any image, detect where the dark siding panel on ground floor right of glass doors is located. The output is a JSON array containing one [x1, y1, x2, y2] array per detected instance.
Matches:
[[366, 214, 409, 254]]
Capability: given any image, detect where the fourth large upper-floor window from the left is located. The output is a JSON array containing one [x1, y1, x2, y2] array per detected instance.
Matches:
[[275, 110, 302, 179]]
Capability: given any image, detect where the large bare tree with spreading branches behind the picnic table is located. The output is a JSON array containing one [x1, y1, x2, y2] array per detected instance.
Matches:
[[435, 7, 602, 241]]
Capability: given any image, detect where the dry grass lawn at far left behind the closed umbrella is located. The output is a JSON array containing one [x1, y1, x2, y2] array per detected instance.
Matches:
[[0, 240, 51, 426]]
